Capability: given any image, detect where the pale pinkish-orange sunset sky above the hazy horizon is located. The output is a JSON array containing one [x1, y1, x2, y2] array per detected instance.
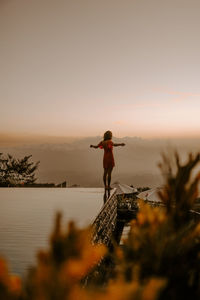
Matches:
[[0, 0, 200, 137]]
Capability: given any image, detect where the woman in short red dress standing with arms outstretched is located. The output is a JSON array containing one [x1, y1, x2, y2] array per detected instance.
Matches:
[[90, 130, 125, 190]]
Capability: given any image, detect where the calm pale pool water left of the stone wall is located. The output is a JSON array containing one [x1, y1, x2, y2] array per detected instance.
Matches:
[[0, 188, 103, 275]]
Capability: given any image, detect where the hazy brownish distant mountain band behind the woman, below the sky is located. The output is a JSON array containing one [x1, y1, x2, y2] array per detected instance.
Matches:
[[0, 137, 200, 187]]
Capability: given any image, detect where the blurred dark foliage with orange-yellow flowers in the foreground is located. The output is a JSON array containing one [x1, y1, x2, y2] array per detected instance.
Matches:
[[0, 153, 200, 300]]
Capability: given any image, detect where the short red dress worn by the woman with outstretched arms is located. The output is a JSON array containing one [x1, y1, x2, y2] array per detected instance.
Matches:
[[98, 140, 115, 169]]
